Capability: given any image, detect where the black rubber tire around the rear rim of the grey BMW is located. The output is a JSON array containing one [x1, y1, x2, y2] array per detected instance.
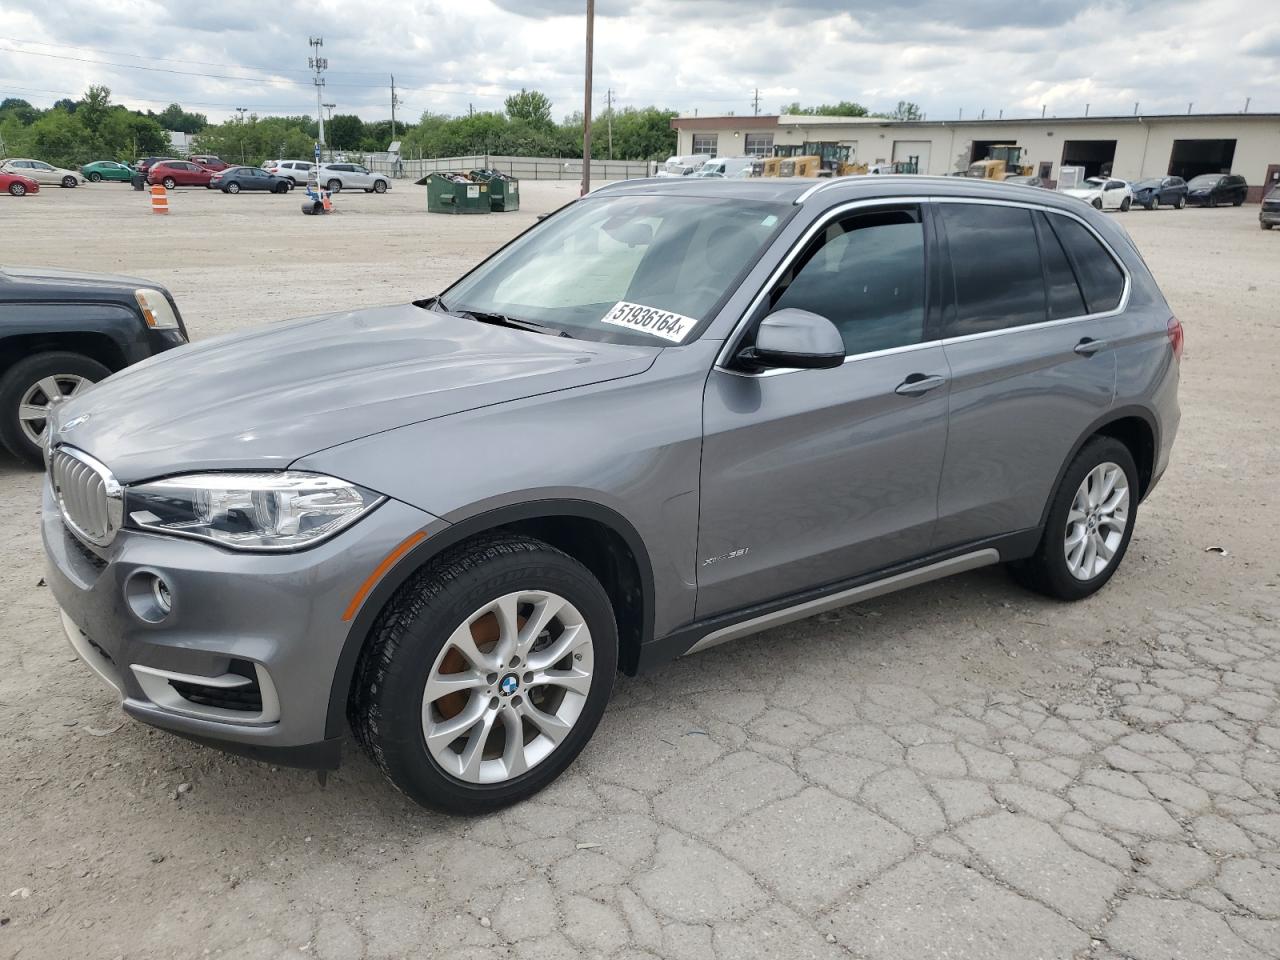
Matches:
[[1009, 436, 1138, 600]]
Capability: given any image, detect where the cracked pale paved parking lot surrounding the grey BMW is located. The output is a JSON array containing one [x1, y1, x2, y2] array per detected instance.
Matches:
[[0, 182, 1280, 960]]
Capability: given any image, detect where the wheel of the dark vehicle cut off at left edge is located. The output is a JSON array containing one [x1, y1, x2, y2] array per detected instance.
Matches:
[[0, 352, 111, 466]]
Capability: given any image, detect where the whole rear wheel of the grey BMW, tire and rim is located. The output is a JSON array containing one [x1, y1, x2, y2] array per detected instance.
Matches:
[[1010, 436, 1138, 600]]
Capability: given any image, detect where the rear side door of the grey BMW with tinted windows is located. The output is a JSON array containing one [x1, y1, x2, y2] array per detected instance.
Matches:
[[933, 201, 1128, 549]]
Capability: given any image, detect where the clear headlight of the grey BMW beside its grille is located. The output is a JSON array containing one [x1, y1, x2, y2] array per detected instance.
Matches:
[[124, 470, 385, 550]]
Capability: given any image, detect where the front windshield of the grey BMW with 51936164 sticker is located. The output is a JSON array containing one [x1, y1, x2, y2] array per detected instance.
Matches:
[[440, 196, 792, 346]]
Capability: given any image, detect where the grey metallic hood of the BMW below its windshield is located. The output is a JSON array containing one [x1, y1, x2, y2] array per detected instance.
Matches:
[[54, 303, 662, 483]]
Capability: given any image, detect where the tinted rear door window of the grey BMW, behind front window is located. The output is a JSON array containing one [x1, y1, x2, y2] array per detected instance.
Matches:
[[938, 204, 1046, 337]]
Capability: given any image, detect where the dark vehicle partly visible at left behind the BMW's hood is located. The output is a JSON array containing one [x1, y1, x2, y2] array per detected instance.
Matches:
[[0, 266, 187, 465]]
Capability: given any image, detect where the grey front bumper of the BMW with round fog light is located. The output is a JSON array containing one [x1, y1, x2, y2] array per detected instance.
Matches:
[[41, 480, 435, 768]]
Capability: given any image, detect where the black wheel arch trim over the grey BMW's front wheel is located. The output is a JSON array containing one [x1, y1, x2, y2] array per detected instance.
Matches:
[[325, 499, 654, 737]]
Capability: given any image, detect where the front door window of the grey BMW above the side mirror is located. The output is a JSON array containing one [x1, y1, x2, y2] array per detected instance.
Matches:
[[771, 206, 924, 356]]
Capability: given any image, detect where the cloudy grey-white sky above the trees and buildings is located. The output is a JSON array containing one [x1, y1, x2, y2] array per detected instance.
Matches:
[[0, 0, 1280, 119]]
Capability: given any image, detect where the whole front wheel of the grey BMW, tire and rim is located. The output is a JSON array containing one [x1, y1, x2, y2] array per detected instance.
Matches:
[[348, 536, 618, 814]]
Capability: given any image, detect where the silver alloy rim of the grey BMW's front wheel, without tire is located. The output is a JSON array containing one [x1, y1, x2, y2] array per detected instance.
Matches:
[[422, 590, 595, 783]]
